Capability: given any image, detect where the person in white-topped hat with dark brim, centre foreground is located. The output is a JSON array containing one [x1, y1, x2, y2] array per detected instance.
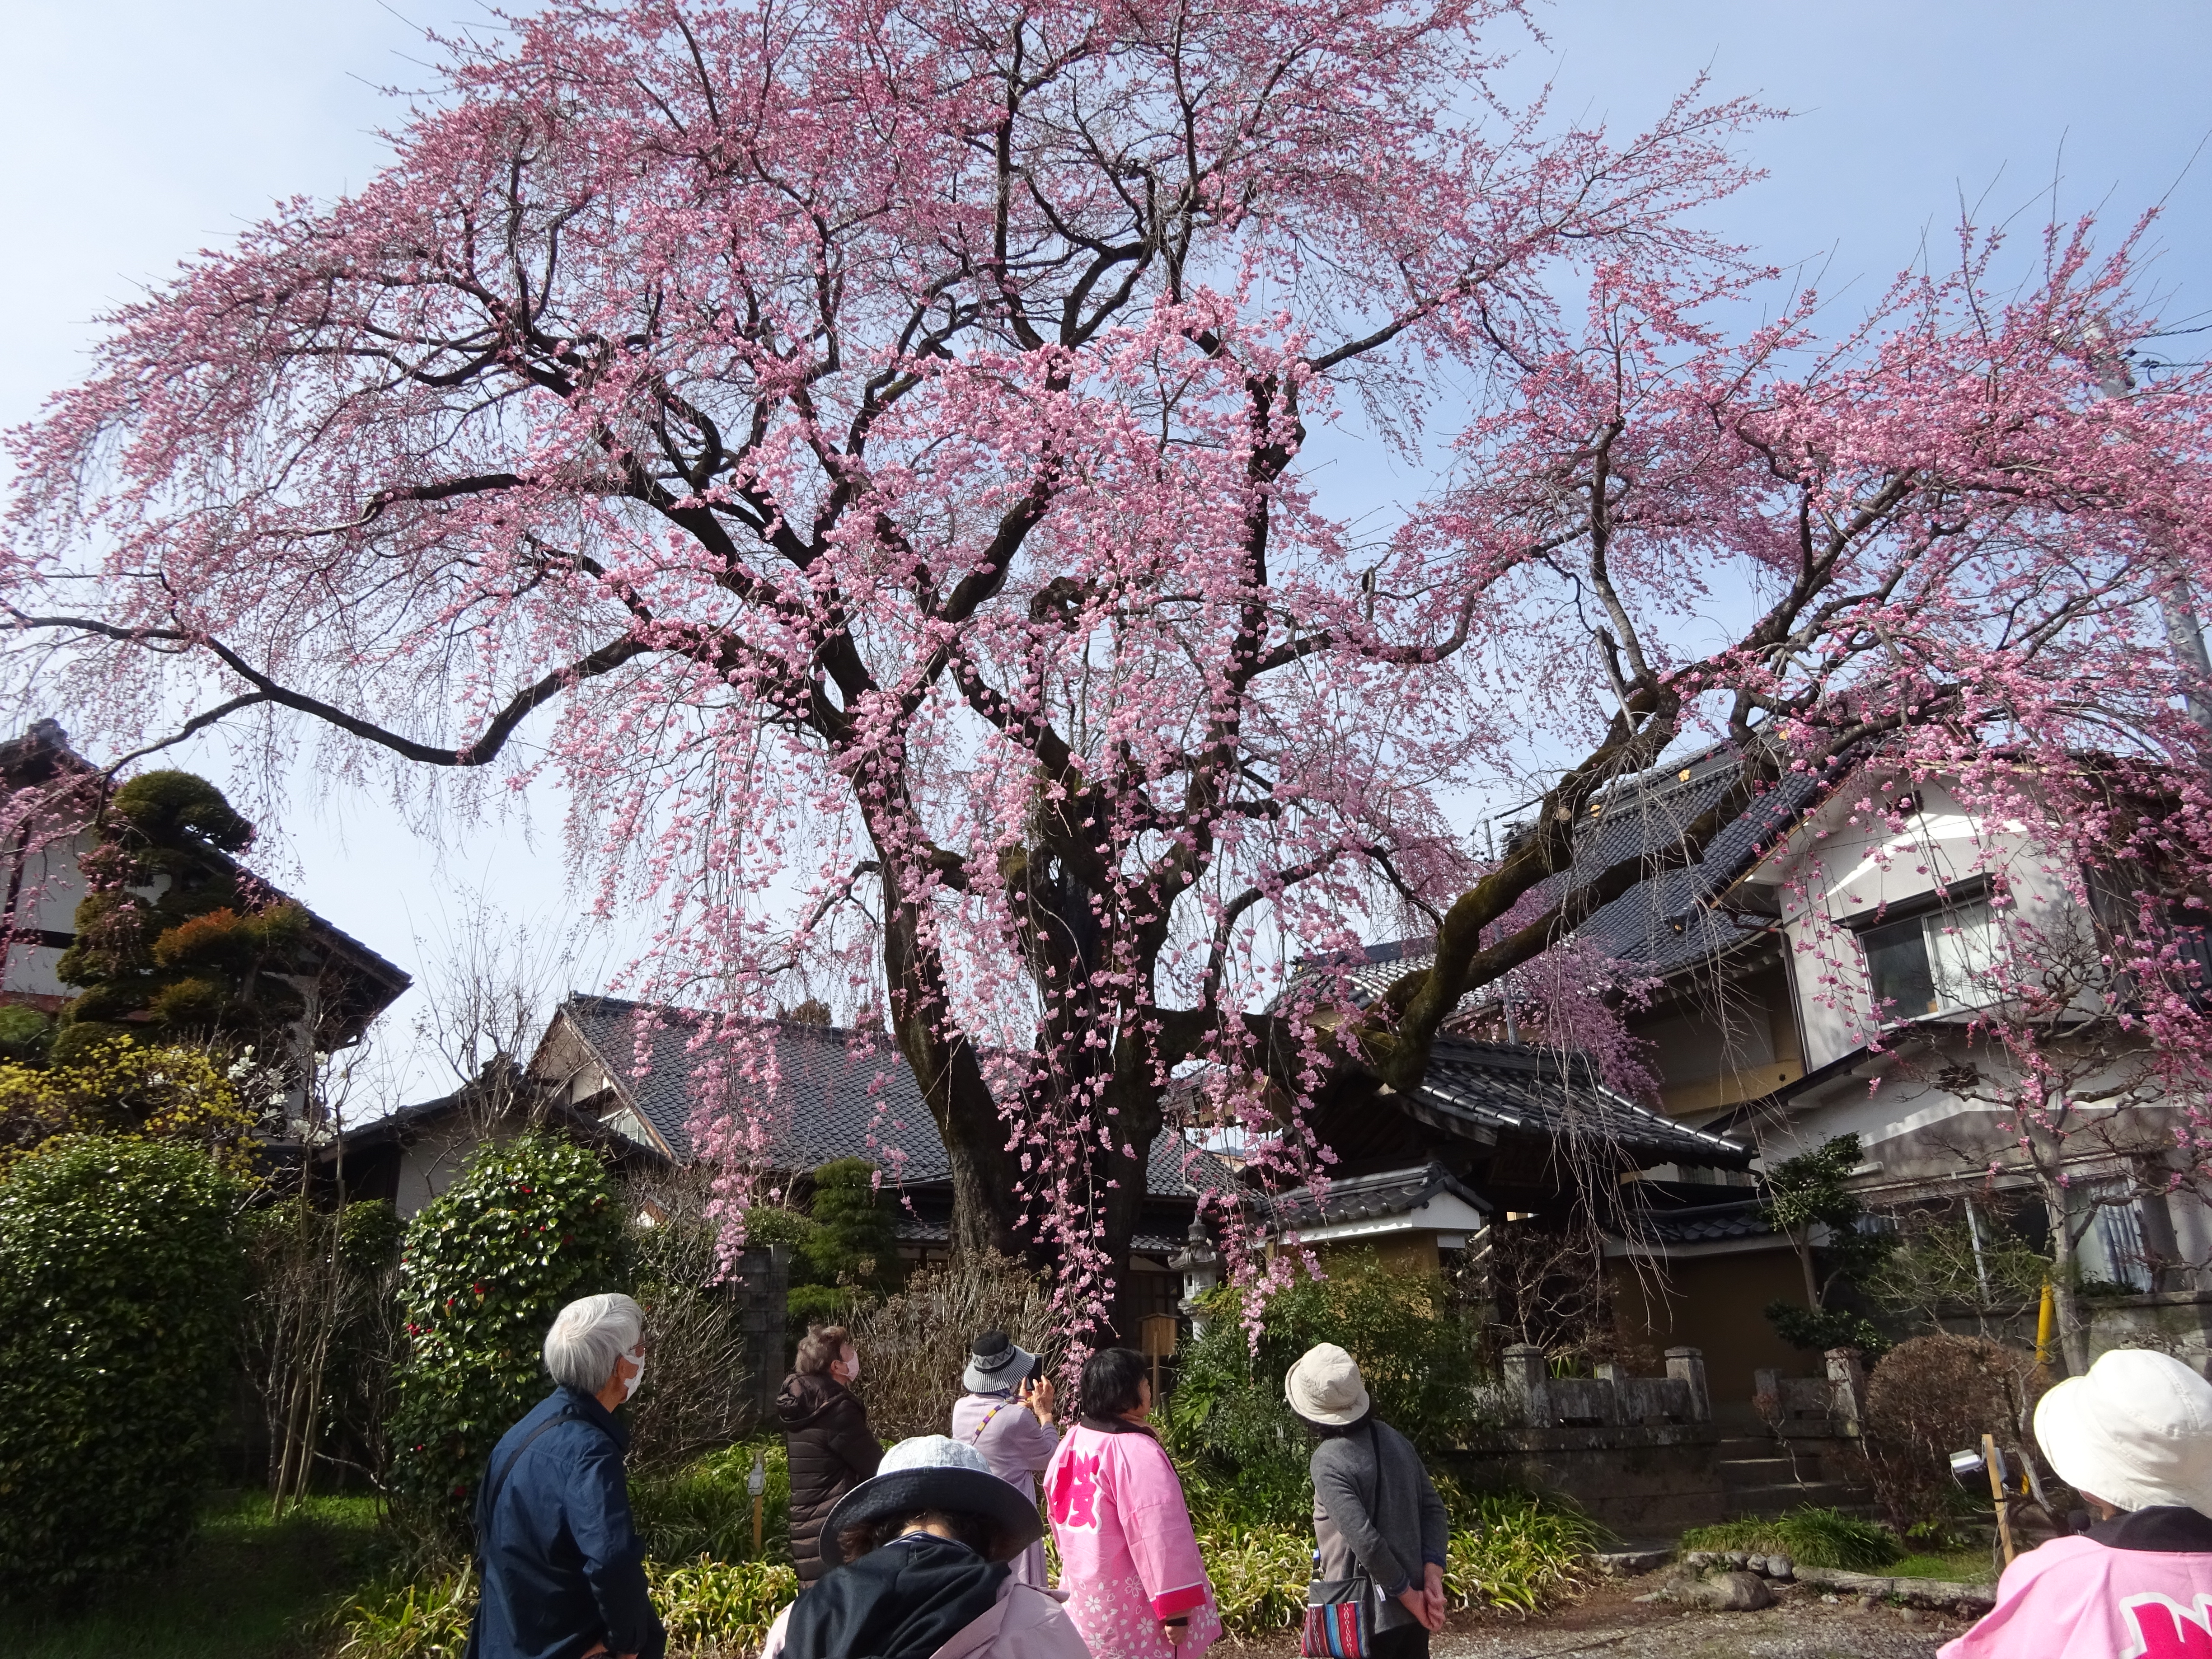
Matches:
[[761, 1434, 1088, 1659]]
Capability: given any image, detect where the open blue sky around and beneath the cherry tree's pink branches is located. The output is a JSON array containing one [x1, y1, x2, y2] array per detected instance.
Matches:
[[0, 0, 2212, 1110]]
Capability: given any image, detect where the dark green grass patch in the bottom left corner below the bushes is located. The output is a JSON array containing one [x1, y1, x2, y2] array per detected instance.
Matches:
[[15, 1493, 376, 1659]]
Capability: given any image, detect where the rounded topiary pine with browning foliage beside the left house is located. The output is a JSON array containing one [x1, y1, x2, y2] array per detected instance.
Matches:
[[51, 770, 308, 1064]]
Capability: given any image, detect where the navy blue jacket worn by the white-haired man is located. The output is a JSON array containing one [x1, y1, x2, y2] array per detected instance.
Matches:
[[469, 1389, 668, 1659]]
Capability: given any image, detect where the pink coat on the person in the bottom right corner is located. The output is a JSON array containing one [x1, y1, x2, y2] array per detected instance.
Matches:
[[1938, 1537, 2212, 1659]]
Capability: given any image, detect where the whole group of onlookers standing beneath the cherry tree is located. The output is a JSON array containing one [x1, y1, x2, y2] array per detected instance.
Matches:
[[469, 1296, 2212, 1659]]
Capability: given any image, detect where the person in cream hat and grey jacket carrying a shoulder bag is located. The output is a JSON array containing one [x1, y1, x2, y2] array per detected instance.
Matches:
[[1283, 1343, 1451, 1659]]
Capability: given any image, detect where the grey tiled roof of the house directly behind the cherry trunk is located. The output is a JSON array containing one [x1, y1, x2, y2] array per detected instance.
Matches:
[[562, 995, 1234, 1199]]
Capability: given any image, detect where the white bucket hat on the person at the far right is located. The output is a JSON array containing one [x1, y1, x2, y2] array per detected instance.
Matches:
[[2035, 1347, 2212, 1515]]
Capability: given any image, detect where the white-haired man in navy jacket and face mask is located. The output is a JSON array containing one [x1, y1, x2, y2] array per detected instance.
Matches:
[[469, 1294, 668, 1659]]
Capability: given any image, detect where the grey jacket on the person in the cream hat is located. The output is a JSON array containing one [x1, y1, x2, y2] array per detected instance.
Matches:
[[1312, 1418, 1451, 1630]]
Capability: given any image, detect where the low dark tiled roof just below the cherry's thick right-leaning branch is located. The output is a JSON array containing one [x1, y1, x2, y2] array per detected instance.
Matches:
[[1414, 1035, 1752, 1170]]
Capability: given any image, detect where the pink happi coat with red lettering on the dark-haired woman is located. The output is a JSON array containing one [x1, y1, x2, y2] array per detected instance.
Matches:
[[1044, 1422, 1221, 1659]]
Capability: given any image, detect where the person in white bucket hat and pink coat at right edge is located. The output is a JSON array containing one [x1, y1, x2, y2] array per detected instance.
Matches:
[[1940, 1350, 2212, 1659]]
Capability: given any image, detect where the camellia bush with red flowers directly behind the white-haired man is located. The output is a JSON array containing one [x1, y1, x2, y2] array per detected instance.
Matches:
[[389, 1135, 624, 1537]]
